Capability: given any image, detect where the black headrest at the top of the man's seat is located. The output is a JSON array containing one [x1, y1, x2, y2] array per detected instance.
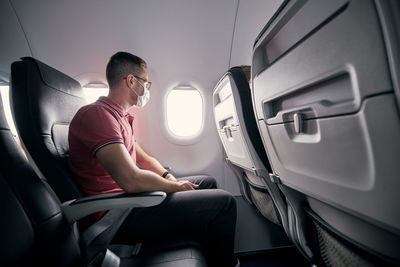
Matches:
[[21, 57, 85, 97]]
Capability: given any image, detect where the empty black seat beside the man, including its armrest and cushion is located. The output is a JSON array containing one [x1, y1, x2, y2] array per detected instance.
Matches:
[[0, 89, 207, 267]]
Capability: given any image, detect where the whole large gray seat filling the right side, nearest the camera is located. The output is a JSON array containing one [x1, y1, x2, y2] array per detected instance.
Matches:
[[252, 0, 400, 266]]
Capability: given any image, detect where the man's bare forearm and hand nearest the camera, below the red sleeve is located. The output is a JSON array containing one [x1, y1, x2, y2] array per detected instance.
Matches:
[[96, 143, 198, 193]]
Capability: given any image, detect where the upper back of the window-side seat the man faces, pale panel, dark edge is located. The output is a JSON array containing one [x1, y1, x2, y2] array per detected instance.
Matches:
[[213, 67, 271, 172]]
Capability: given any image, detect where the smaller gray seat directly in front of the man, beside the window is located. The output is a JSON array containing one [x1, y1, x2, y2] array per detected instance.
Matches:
[[213, 66, 286, 229]]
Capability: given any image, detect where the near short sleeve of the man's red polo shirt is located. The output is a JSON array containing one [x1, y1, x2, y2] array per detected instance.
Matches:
[[73, 106, 123, 156]]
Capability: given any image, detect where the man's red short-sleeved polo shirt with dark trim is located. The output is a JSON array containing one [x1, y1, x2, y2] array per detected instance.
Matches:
[[68, 97, 136, 195]]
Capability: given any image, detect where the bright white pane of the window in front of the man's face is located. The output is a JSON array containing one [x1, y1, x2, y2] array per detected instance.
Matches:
[[167, 87, 203, 137]]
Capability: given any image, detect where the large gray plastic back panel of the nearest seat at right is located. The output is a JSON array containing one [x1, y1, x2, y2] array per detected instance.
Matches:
[[252, 0, 400, 262]]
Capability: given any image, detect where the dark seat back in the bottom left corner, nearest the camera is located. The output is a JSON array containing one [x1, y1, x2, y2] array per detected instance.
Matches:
[[0, 91, 83, 266]]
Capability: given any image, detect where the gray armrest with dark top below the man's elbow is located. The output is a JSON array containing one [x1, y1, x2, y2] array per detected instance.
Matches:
[[61, 191, 167, 223]]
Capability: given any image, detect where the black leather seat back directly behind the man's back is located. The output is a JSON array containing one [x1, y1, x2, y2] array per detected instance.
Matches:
[[11, 58, 86, 202]]
